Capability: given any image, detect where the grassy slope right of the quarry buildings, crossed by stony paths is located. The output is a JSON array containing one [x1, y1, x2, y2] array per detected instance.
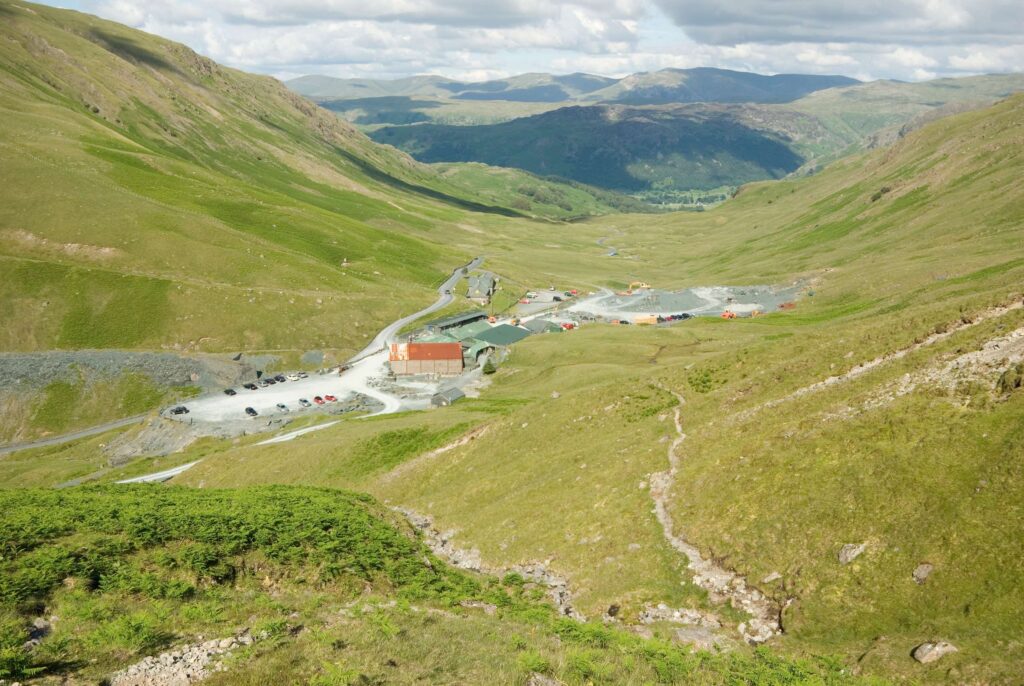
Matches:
[[149, 97, 1024, 683]]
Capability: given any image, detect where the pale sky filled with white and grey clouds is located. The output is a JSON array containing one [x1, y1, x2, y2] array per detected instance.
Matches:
[[41, 0, 1024, 81]]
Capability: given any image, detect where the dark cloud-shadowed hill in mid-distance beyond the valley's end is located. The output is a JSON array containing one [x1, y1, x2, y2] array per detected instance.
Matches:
[[371, 105, 804, 192]]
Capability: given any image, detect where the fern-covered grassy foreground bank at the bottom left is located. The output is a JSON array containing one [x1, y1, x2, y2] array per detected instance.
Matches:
[[0, 486, 872, 685]]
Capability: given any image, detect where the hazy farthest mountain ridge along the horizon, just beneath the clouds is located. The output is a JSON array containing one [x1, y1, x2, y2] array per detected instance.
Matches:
[[286, 68, 860, 104]]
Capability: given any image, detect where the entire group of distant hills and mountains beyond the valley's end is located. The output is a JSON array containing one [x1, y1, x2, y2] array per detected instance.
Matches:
[[291, 70, 1024, 204]]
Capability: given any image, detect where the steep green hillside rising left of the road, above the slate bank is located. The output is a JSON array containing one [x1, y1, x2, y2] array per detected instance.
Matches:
[[0, 2, 630, 360]]
